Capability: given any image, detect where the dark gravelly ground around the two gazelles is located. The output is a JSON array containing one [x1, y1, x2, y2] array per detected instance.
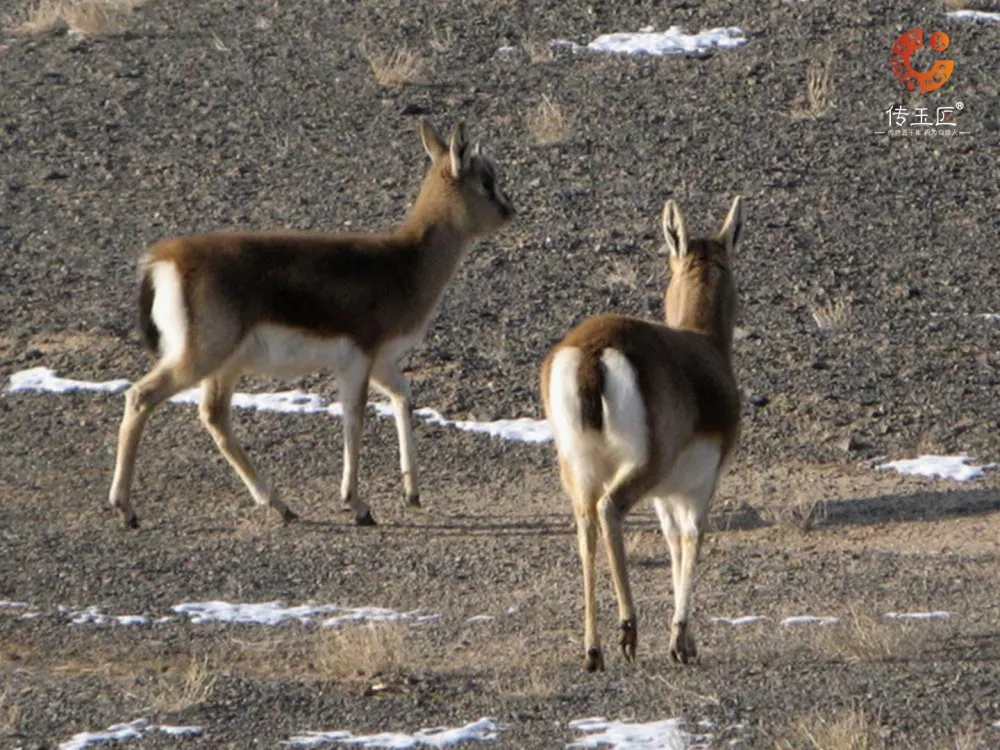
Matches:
[[0, 0, 1000, 748]]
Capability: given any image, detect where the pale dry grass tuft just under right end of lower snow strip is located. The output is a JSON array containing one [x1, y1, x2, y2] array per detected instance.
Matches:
[[316, 623, 407, 679]]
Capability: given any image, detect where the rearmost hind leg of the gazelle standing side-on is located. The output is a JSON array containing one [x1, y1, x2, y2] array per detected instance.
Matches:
[[108, 362, 194, 529]]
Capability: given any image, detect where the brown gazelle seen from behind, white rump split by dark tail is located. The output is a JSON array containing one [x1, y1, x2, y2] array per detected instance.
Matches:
[[541, 197, 743, 671]]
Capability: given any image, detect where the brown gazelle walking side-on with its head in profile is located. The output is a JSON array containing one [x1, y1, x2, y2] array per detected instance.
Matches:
[[110, 121, 514, 528]]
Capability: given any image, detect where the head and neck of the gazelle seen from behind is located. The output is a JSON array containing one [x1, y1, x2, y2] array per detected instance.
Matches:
[[663, 196, 743, 353]]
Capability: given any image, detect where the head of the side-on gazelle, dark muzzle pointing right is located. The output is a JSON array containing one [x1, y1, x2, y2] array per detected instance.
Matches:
[[414, 120, 514, 239]]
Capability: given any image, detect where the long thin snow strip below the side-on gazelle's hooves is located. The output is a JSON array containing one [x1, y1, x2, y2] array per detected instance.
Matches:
[[173, 601, 439, 628]]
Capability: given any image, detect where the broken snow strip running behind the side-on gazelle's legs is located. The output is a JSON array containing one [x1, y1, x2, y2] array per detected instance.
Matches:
[[8, 367, 552, 443]]
